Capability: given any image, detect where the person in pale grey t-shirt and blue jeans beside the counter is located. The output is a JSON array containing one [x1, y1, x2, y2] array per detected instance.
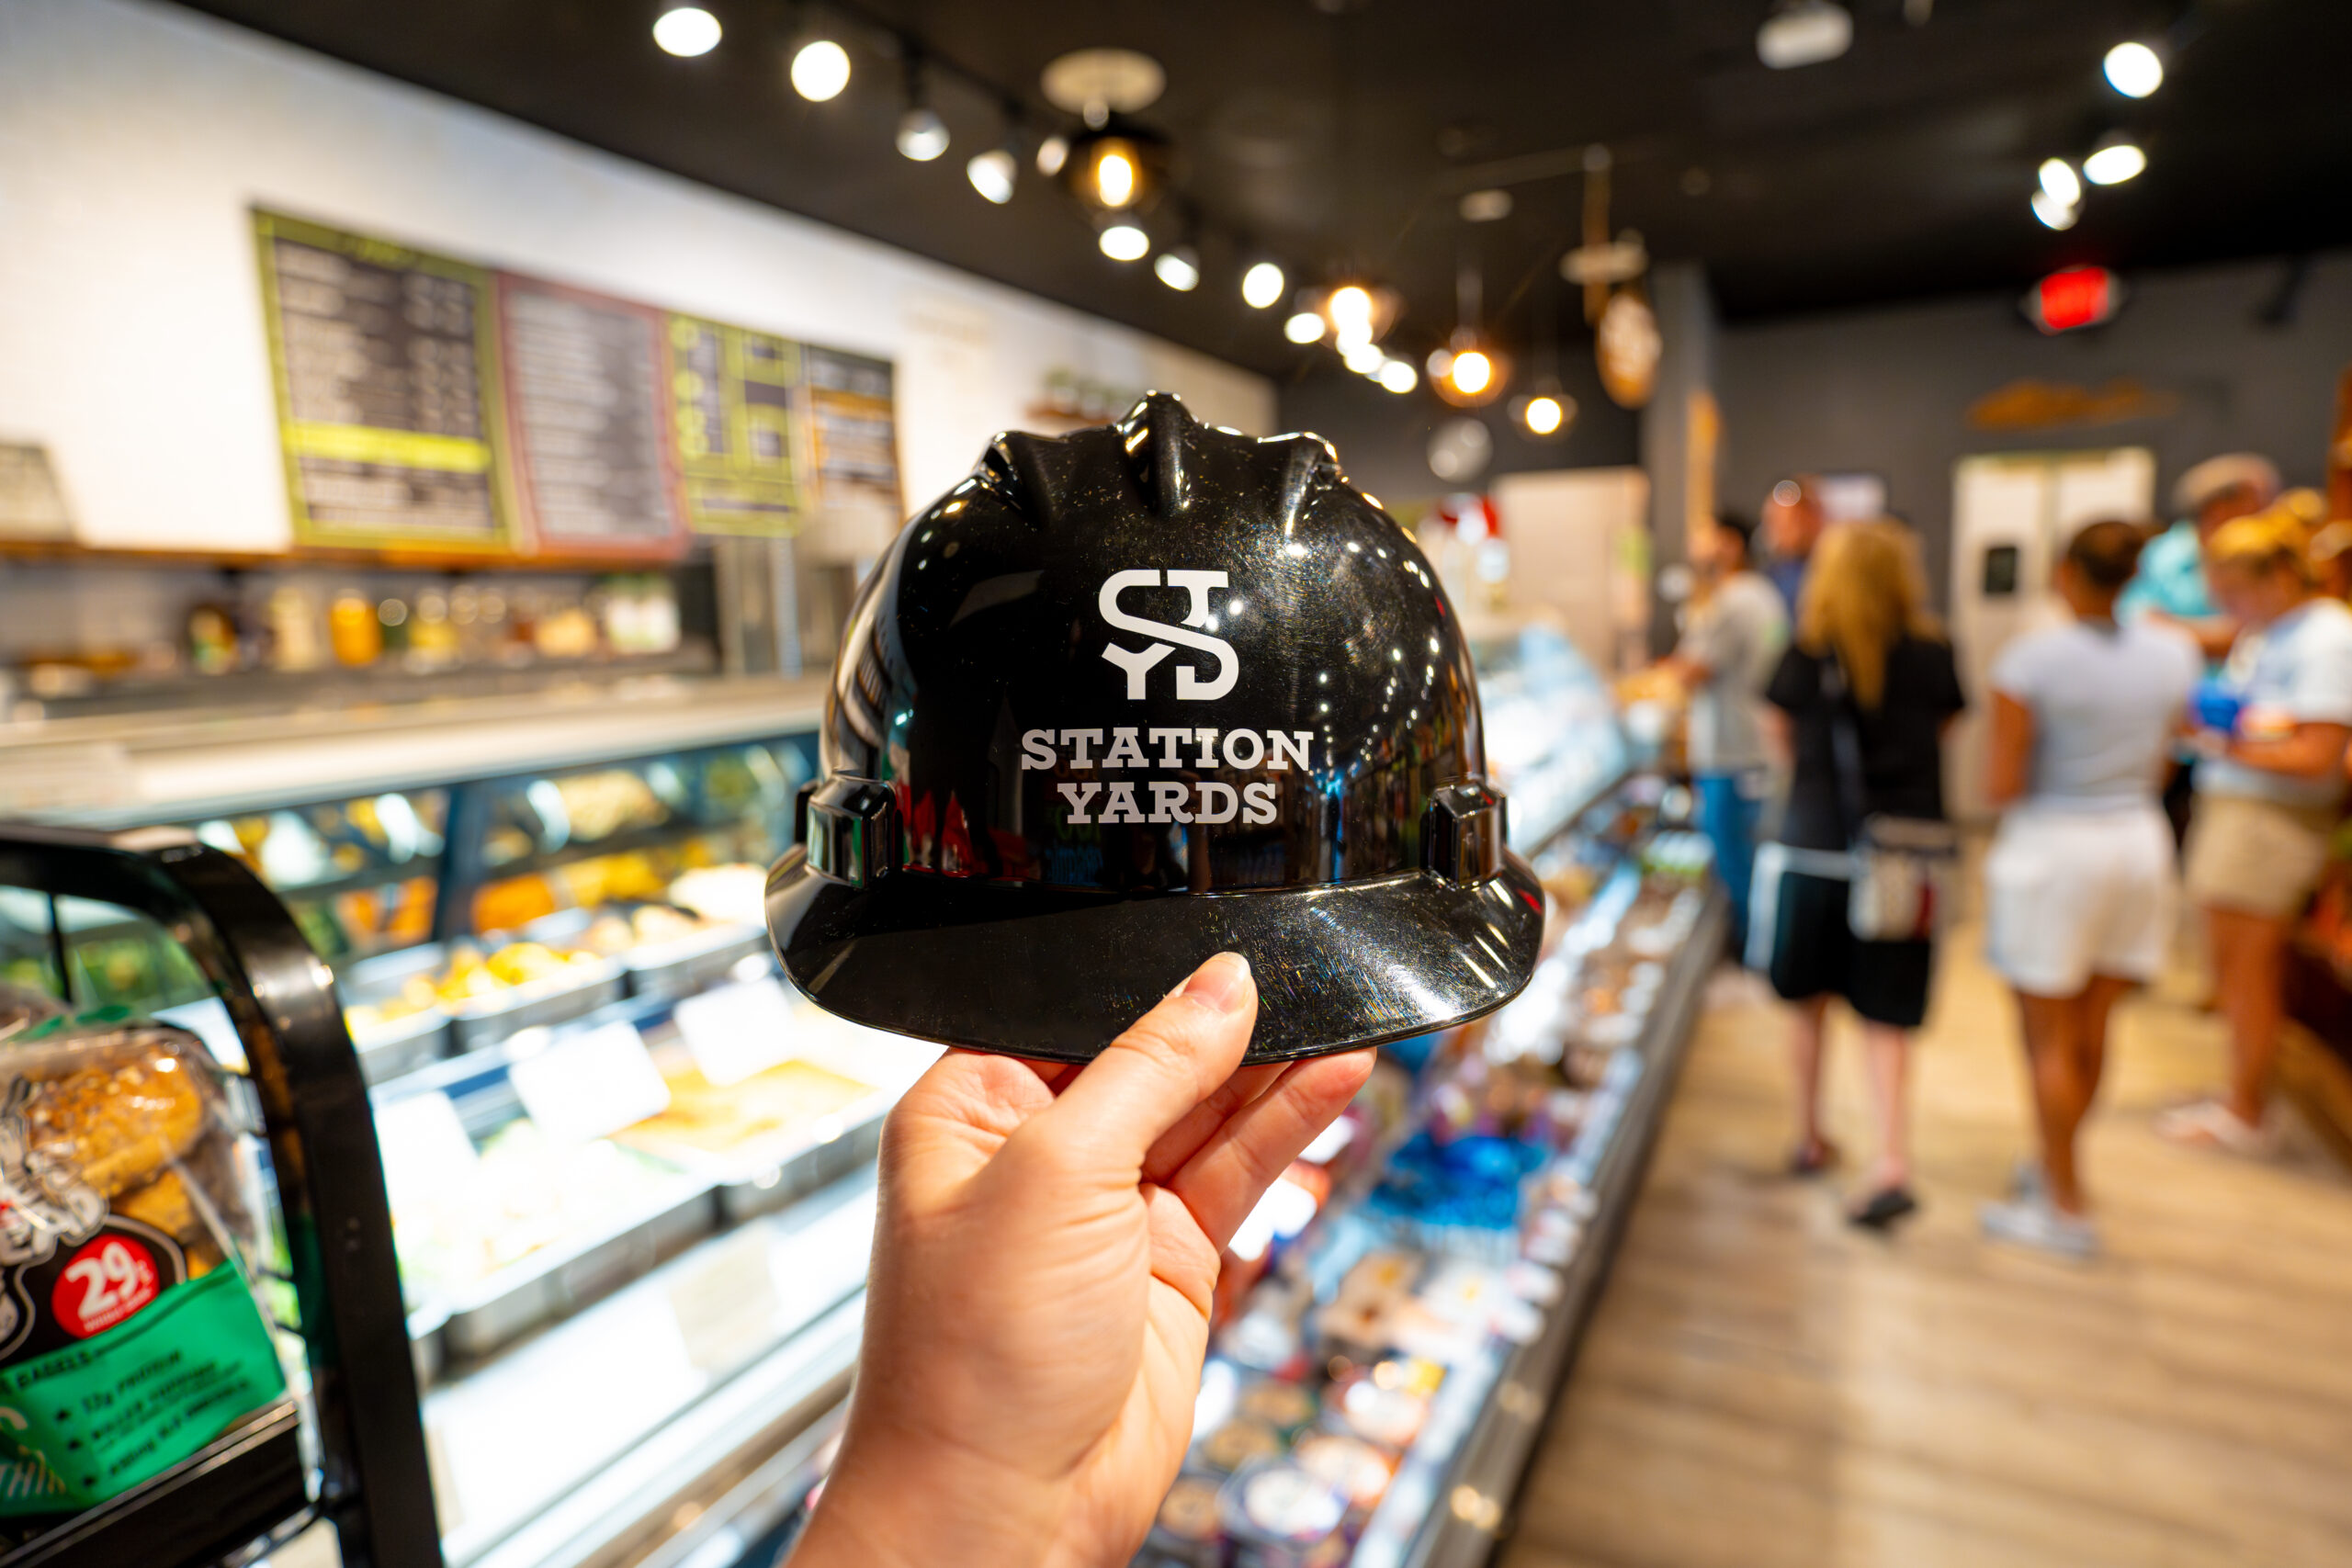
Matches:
[[1665, 513, 1788, 952]]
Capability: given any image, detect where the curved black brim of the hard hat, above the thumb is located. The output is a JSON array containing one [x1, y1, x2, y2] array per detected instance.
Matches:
[[767, 849, 1543, 1063]]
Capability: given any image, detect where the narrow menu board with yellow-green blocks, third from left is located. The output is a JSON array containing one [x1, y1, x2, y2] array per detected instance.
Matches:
[[671, 315, 799, 536]]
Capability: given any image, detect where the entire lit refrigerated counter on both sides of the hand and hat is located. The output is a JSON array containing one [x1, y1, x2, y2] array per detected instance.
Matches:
[[0, 626, 1719, 1568]]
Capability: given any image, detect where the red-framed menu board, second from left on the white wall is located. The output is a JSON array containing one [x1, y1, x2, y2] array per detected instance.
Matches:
[[499, 273, 687, 558]]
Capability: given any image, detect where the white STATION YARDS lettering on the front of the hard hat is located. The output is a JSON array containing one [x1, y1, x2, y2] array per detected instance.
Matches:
[[1021, 727, 1315, 825]]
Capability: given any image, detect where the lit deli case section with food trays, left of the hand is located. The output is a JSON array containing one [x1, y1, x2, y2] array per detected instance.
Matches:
[[0, 682, 917, 1568]]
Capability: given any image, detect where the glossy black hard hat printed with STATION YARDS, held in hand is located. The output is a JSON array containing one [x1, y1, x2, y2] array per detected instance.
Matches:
[[767, 392, 1543, 1060]]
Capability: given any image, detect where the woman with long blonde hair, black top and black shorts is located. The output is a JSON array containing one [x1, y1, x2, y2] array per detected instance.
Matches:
[[1747, 522, 1966, 1229]]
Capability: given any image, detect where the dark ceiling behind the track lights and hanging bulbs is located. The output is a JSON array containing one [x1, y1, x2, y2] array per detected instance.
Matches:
[[170, 0, 2352, 376]]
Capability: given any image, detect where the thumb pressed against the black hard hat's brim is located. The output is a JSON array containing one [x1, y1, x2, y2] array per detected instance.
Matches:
[[1035, 952, 1259, 1180]]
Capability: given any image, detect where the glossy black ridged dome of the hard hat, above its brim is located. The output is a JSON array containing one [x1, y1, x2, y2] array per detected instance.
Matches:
[[826, 398, 1482, 891]]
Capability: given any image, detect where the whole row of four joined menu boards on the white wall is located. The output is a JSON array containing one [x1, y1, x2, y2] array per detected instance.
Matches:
[[254, 209, 900, 559]]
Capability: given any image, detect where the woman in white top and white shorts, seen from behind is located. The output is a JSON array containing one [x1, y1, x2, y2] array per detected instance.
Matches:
[[1981, 522, 2201, 1258]]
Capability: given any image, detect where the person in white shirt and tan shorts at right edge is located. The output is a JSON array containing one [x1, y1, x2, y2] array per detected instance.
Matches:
[[2157, 513, 2352, 1155]]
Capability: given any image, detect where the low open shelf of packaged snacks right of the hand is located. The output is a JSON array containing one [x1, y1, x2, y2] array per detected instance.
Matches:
[[1136, 778, 1726, 1568]]
